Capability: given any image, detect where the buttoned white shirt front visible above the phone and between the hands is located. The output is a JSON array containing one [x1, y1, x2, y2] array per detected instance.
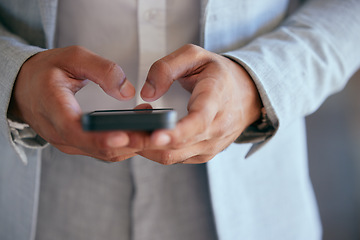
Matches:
[[57, 0, 200, 116]]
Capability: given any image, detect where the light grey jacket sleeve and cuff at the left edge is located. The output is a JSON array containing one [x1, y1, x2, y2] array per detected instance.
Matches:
[[0, 23, 45, 163]]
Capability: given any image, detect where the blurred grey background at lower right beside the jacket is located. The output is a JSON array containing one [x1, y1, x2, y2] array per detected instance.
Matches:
[[306, 68, 360, 240]]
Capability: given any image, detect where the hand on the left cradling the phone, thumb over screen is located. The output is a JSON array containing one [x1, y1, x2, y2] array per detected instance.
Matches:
[[9, 46, 140, 161]]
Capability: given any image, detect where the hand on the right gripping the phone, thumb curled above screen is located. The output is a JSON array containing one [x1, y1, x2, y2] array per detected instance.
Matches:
[[139, 45, 261, 165]]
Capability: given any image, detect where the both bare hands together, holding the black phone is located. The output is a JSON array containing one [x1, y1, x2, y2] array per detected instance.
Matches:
[[9, 45, 261, 165]]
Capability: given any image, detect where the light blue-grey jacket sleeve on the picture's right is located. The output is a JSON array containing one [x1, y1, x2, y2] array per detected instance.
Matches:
[[224, 0, 360, 155]]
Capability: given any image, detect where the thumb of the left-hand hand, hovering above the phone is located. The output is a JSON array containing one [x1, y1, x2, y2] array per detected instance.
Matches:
[[60, 46, 135, 100]]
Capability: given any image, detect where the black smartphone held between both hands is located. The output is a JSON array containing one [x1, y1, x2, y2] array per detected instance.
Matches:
[[82, 108, 177, 131]]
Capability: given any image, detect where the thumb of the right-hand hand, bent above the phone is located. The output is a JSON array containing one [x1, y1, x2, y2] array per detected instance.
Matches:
[[141, 44, 205, 101]]
